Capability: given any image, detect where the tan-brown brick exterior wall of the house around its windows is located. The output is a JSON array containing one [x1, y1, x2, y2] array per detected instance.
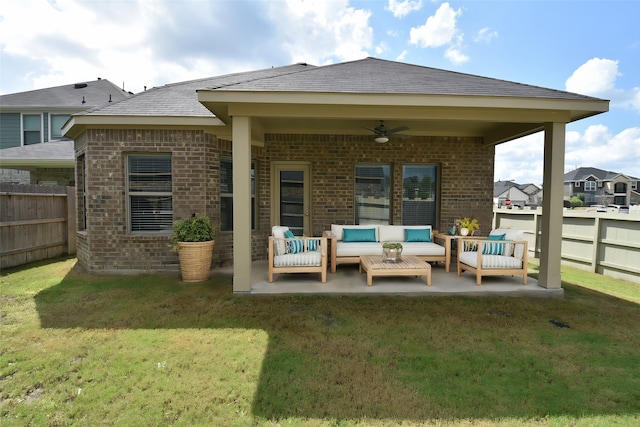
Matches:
[[75, 129, 494, 272]]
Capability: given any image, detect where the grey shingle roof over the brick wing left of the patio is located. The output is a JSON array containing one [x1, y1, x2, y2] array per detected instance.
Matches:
[[82, 64, 312, 117]]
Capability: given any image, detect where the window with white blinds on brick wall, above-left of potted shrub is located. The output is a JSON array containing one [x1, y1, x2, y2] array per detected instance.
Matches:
[[127, 155, 173, 232]]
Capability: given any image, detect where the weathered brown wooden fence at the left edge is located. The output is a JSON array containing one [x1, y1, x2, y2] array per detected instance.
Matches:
[[0, 183, 76, 269]]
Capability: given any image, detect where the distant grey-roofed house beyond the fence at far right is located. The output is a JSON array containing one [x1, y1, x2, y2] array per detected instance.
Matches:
[[564, 167, 640, 206]]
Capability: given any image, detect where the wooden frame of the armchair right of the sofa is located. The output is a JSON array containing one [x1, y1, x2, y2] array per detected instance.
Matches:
[[458, 237, 529, 286]]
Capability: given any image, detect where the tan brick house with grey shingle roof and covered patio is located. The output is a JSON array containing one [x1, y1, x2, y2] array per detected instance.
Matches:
[[63, 58, 609, 292]]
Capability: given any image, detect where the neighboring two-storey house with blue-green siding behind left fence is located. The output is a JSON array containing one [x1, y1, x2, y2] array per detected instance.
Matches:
[[0, 79, 131, 185]]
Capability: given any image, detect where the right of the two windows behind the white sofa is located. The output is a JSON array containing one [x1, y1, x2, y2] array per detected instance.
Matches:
[[402, 165, 438, 227]]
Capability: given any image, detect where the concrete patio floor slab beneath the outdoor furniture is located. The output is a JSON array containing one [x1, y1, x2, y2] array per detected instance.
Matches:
[[218, 261, 564, 298]]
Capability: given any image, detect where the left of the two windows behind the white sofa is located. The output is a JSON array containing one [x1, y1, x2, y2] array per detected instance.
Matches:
[[354, 165, 391, 224]]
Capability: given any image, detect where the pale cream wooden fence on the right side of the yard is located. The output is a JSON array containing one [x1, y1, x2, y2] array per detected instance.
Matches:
[[493, 208, 640, 283]]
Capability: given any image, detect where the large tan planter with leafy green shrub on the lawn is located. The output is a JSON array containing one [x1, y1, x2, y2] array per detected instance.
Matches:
[[173, 215, 215, 282]]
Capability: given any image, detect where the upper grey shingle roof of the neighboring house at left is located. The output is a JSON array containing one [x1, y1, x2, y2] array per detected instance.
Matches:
[[0, 79, 130, 111]]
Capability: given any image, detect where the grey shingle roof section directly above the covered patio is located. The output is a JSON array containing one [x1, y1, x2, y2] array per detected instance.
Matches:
[[208, 58, 596, 100]]
